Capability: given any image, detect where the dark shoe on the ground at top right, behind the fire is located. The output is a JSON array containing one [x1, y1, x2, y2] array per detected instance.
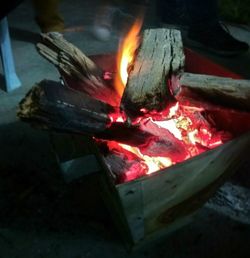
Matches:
[[184, 22, 249, 57]]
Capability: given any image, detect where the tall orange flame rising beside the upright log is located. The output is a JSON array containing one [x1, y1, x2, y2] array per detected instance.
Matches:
[[115, 18, 143, 97]]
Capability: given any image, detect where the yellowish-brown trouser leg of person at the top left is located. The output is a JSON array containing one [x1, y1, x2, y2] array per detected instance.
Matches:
[[32, 0, 64, 33]]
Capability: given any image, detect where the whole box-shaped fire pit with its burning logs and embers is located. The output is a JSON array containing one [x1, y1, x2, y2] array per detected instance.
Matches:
[[18, 25, 250, 245]]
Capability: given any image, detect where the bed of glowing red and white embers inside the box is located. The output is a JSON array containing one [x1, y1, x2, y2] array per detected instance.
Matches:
[[99, 99, 231, 183]]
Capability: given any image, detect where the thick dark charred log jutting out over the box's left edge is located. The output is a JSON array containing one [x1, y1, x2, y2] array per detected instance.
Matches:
[[17, 80, 115, 134]]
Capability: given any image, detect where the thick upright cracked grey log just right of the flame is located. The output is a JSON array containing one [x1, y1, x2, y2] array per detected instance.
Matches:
[[121, 29, 184, 117]]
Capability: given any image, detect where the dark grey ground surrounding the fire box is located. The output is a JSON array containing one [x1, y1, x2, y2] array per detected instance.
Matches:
[[0, 0, 250, 258]]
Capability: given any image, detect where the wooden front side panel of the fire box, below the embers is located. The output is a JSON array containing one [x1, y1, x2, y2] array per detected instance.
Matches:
[[117, 133, 250, 243]]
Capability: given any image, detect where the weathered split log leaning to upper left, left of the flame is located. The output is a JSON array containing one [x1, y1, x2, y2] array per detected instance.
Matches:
[[37, 34, 120, 106]]
